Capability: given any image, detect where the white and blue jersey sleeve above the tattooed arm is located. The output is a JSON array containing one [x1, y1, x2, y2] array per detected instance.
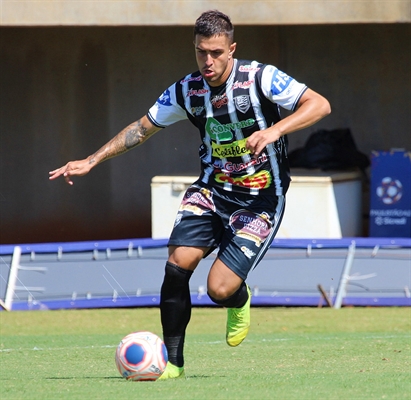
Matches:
[[147, 84, 187, 128]]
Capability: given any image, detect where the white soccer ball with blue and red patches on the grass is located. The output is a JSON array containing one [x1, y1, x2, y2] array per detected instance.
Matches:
[[115, 331, 168, 381]]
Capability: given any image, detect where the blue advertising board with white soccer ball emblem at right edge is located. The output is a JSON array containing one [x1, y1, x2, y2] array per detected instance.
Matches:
[[370, 150, 411, 238]]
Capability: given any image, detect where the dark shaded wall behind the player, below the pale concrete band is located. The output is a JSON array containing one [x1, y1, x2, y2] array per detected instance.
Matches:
[[0, 24, 411, 243]]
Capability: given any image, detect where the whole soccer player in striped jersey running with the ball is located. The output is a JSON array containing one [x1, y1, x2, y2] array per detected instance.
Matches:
[[50, 11, 330, 379]]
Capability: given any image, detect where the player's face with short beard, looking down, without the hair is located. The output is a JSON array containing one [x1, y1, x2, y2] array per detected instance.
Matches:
[[194, 35, 236, 86]]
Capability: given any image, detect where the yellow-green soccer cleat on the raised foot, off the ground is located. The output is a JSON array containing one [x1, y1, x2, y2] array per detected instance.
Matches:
[[226, 286, 251, 347]]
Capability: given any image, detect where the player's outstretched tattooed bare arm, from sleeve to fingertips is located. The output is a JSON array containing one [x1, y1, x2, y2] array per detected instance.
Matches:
[[49, 116, 161, 185]]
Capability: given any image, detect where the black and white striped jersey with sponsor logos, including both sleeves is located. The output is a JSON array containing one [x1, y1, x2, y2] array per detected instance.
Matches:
[[148, 60, 307, 195]]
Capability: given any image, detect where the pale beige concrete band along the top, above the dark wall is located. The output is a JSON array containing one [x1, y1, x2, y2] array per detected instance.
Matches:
[[0, 0, 411, 26]]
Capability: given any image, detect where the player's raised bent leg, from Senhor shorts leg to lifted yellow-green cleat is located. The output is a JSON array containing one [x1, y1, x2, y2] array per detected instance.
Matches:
[[208, 195, 284, 346]]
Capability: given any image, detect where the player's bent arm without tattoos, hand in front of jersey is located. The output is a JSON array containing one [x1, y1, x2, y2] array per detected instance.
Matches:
[[247, 89, 331, 157]]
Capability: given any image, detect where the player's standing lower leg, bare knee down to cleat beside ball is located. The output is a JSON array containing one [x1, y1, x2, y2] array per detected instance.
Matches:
[[160, 246, 207, 379]]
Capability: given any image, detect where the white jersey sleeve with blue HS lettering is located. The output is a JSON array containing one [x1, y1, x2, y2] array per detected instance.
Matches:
[[261, 65, 307, 110]]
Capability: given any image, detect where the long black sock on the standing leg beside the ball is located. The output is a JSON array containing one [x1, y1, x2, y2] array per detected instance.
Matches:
[[160, 261, 193, 367]]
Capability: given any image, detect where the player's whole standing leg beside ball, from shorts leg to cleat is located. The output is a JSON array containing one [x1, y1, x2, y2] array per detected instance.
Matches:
[[160, 183, 224, 379]]
